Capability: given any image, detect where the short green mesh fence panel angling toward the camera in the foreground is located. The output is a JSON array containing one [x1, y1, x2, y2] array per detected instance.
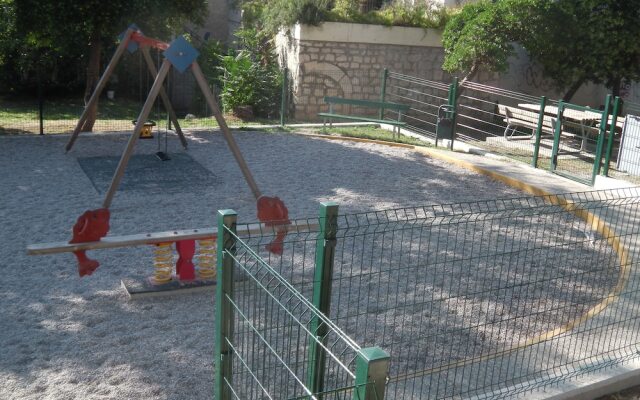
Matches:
[[215, 210, 389, 400]]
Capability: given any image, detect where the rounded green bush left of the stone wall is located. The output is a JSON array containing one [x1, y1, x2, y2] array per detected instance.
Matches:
[[220, 29, 282, 117]]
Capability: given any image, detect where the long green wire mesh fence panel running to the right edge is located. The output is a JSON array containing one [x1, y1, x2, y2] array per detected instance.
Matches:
[[220, 189, 640, 399]]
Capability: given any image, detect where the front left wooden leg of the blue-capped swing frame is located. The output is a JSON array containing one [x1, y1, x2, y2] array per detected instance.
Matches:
[[102, 58, 171, 208]]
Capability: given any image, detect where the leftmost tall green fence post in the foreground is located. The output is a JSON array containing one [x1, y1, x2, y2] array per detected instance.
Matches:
[[215, 210, 238, 400]]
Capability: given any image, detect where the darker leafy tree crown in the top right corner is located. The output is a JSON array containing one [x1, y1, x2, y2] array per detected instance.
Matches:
[[522, 0, 640, 100]]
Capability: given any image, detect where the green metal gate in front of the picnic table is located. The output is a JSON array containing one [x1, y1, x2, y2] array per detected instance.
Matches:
[[545, 96, 611, 186]]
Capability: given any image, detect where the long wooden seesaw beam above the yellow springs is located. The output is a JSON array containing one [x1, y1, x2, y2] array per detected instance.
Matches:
[[27, 224, 319, 256]]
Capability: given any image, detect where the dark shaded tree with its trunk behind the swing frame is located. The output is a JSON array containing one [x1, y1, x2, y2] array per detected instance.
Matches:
[[15, 0, 206, 131]]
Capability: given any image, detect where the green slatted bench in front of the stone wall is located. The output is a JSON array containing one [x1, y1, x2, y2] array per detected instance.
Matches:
[[318, 96, 411, 134]]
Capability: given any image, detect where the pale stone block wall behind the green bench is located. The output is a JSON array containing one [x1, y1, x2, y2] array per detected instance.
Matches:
[[276, 23, 450, 121]]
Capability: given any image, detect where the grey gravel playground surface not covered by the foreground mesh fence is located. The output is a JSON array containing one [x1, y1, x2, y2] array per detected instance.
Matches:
[[0, 133, 522, 399]]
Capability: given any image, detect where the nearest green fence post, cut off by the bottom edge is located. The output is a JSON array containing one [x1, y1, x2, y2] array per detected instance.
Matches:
[[353, 347, 389, 400]]
